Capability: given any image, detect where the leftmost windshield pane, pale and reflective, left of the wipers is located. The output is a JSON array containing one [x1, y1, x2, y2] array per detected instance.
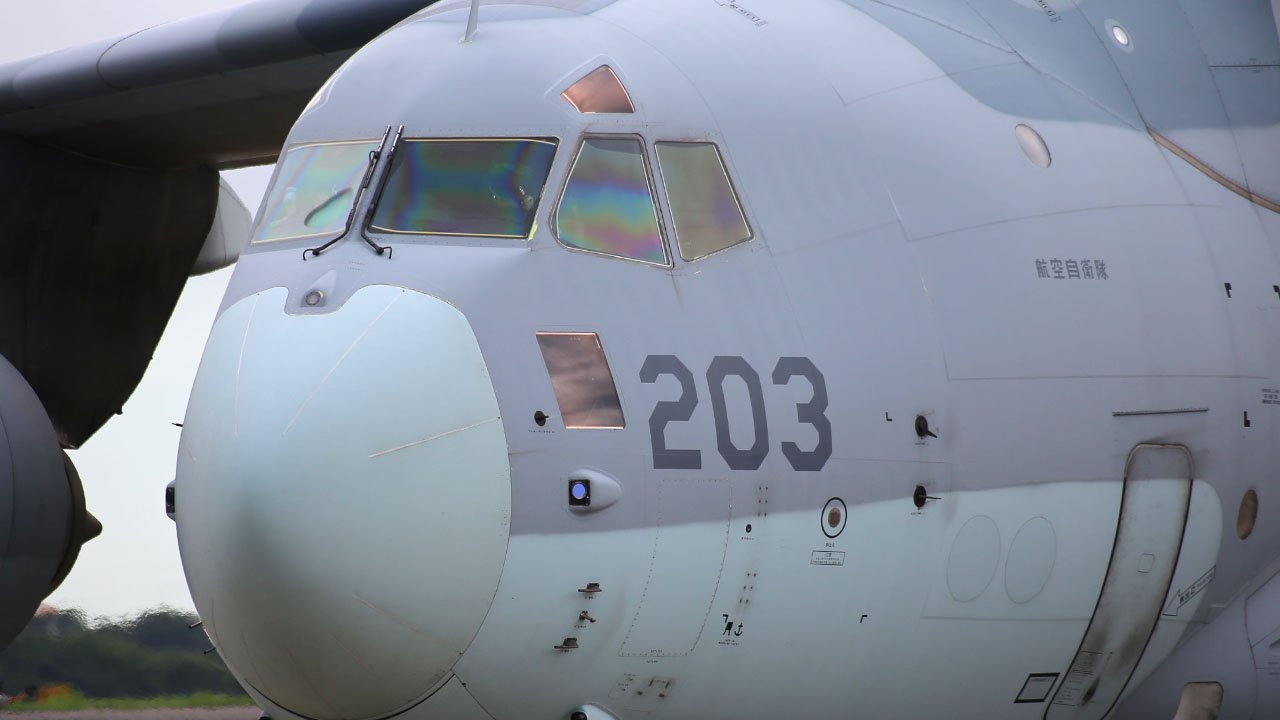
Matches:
[[253, 140, 378, 242]]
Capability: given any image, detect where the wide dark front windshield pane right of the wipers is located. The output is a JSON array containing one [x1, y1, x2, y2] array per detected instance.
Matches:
[[371, 138, 557, 238]]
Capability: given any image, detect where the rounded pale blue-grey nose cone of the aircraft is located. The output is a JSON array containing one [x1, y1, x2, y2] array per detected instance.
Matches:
[[175, 286, 511, 720]]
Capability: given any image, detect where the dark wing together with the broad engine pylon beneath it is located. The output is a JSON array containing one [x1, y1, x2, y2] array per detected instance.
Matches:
[[0, 0, 445, 446]]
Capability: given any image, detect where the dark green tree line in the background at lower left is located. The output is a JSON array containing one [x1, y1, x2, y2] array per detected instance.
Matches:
[[0, 609, 243, 698]]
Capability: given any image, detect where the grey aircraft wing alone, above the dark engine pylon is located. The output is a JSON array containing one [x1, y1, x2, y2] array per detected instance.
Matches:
[[0, 0, 433, 168]]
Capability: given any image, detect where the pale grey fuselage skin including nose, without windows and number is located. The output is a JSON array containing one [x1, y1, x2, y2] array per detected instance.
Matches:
[[177, 0, 1280, 720]]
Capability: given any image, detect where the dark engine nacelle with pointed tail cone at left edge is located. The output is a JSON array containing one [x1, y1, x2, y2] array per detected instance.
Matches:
[[0, 357, 102, 647]]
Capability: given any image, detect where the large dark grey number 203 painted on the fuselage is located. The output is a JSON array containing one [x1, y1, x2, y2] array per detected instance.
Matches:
[[640, 355, 832, 471]]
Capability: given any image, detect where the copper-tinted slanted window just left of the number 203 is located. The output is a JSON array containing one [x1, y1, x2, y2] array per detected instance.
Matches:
[[538, 333, 626, 429]]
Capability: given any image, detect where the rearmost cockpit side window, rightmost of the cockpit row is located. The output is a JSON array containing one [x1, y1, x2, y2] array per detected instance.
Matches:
[[657, 142, 751, 260]]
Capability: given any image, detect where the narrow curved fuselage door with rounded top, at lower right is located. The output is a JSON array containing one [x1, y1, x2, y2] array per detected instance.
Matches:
[[1044, 443, 1196, 720]]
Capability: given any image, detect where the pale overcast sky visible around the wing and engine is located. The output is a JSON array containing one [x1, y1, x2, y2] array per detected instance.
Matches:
[[0, 0, 279, 616]]
